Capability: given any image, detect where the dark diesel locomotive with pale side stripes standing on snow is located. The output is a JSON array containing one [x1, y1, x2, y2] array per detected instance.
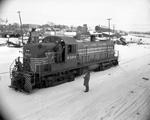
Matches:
[[10, 36, 118, 92]]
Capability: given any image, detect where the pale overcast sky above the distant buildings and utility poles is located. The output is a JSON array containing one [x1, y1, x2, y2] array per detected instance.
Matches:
[[0, 0, 150, 31]]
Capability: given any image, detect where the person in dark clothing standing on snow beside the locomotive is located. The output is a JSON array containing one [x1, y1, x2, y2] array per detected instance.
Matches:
[[84, 70, 90, 92]]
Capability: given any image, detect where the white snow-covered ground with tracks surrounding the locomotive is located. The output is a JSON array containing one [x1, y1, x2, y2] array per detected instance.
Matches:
[[0, 39, 150, 120]]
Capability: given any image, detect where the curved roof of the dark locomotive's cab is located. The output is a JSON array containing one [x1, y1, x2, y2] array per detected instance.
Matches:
[[42, 36, 77, 44]]
